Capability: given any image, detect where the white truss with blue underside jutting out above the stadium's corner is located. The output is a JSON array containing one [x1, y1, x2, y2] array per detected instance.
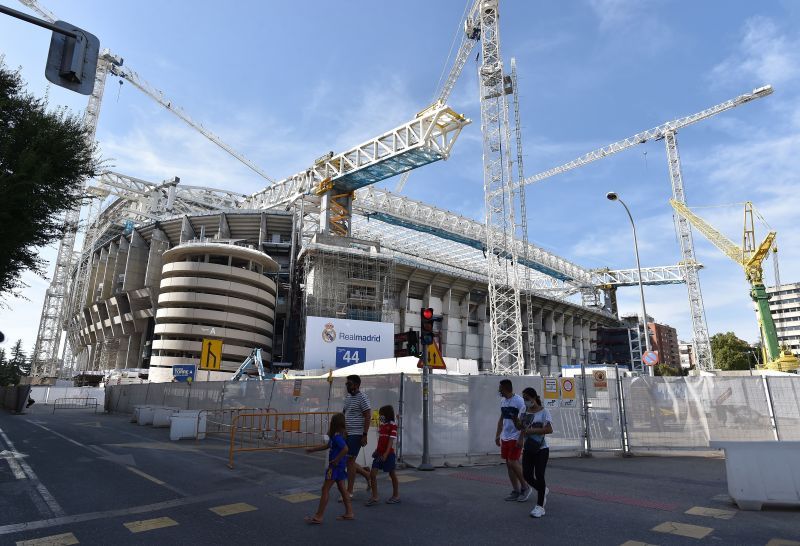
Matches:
[[243, 105, 471, 209]]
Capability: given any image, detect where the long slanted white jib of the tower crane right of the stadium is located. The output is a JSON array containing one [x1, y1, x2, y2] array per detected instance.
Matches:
[[525, 85, 773, 184]]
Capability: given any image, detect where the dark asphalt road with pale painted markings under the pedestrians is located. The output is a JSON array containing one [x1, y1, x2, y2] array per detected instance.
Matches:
[[0, 406, 800, 546]]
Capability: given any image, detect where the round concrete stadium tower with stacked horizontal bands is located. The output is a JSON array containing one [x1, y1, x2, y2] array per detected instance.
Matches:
[[150, 242, 280, 381]]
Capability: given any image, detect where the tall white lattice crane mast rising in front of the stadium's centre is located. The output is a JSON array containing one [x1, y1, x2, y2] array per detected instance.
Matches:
[[476, 0, 524, 375]]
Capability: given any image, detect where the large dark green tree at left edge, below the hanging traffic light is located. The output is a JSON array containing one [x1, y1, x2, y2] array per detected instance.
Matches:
[[0, 65, 100, 297]]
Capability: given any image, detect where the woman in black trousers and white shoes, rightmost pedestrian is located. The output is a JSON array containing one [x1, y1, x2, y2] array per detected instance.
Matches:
[[516, 387, 553, 518]]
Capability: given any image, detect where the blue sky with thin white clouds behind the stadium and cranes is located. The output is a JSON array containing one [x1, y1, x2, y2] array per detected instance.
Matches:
[[0, 0, 800, 348]]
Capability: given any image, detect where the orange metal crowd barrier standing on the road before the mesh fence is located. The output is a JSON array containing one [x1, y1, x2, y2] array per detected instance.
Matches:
[[228, 412, 335, 468]]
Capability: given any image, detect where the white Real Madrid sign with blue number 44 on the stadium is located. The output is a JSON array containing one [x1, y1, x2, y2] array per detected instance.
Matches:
[[304, 317, 394, 370]]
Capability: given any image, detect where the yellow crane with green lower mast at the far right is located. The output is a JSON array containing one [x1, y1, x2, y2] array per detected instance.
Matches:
[[670, 199, 798, 372]]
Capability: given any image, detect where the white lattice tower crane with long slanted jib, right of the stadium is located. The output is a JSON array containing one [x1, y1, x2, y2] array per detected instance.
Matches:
[[525, 85, 772, 370]]
